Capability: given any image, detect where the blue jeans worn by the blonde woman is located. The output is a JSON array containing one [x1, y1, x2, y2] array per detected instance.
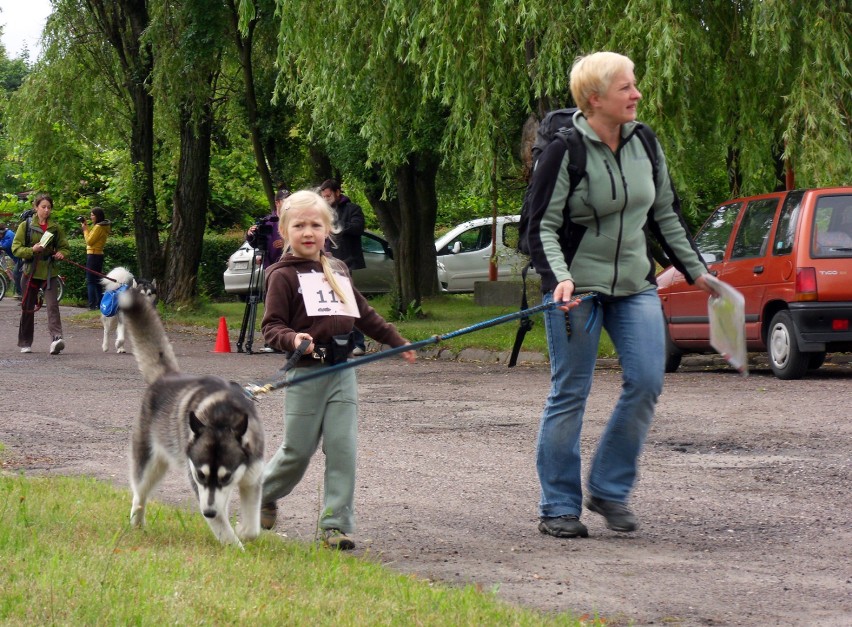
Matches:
[[536, 290, 665, 518]]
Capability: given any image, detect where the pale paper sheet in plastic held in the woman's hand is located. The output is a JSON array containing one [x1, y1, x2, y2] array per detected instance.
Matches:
[[707, 276, 748, 377]]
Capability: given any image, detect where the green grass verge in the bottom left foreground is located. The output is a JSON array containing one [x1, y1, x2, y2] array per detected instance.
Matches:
[[0, 475, 599, 625]]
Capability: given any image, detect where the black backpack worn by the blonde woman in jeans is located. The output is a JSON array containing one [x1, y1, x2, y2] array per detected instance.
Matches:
[[509, 107, 660, 368]]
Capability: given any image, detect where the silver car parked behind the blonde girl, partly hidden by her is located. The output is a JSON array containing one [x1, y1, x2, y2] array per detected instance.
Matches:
[[222, 231, 394, 298]]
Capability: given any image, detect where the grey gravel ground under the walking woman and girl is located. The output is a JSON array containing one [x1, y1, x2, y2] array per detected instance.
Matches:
[[5, 298, 852, 625]]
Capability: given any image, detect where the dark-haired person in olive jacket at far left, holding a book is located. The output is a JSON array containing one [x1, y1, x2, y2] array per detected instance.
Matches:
[[12, 194, 69, 355]]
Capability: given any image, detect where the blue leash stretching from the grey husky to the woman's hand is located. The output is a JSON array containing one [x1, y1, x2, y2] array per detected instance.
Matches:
[[243, 292, 597, 400]]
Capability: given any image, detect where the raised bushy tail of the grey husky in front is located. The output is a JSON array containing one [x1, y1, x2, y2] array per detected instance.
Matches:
[[118, 288, 179, 384]]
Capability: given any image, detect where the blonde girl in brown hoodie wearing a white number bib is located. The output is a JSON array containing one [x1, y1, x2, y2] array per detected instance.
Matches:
[[261, 191, 415, 550]]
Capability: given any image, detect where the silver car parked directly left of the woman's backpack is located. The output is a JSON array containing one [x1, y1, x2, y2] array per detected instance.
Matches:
[[435, 215, 538, 292]]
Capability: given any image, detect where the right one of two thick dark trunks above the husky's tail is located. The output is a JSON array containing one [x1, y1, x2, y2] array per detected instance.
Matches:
[[164, 102, 213, 305]]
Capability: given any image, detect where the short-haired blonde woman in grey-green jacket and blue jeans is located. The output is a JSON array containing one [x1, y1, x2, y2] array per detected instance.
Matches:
[[528, 52, 712, 538]]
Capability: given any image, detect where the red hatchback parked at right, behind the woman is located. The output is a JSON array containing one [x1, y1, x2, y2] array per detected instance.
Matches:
[[657, 187, 852, 379]]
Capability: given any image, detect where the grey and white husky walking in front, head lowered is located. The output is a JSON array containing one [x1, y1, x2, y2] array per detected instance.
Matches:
[[118, 288, 263, 547]]
